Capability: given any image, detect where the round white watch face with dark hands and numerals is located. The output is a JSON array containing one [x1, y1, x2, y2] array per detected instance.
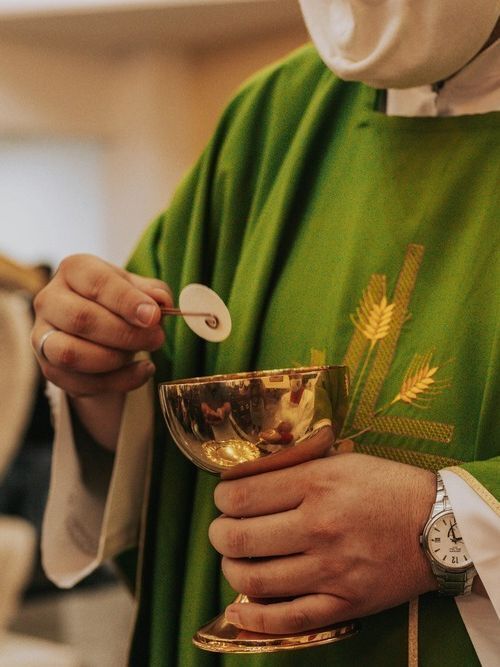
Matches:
[[427, 513, 471, 570]]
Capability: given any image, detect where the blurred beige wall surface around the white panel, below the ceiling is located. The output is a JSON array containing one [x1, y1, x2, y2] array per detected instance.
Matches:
[[0, 25, 306, 262]]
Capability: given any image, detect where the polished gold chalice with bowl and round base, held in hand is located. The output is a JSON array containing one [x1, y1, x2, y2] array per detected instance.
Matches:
[[159, 366, 358, 653]]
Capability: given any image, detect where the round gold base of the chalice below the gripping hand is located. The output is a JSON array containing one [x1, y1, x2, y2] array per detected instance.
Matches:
[[193, 596, 359, 653]]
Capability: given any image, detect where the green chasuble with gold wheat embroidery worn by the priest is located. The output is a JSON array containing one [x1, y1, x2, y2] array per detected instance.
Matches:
[[123, 47, 500, 667]]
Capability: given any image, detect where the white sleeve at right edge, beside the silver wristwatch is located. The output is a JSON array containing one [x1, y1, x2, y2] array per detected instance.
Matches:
[[440, 470, 500, 667]]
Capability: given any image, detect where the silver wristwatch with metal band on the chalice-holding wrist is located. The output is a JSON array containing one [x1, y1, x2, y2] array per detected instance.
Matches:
[[420, 473, 476, 595]]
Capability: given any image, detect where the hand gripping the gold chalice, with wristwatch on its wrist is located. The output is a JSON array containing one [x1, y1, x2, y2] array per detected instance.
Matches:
[[209, 454, 436, 634]]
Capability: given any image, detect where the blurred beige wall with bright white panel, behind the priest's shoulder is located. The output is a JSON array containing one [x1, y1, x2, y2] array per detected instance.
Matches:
[[0, 0, 306, 263]]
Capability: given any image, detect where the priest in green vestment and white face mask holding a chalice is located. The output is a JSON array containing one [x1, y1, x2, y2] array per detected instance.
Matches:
[[34, 0, 500, 667]]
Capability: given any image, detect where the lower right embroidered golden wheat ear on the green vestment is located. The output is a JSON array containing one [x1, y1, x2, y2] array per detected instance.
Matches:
[[380, 352, 450, 411]]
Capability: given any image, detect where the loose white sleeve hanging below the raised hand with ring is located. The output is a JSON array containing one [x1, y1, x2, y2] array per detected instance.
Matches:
[[42, 382, 154, 588]]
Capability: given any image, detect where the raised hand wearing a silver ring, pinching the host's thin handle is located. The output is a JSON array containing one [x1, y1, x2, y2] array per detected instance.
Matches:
[[32, 255, 172, 448]]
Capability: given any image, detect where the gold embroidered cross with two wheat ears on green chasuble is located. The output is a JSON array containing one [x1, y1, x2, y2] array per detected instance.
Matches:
[[342, 244, 454, 444]]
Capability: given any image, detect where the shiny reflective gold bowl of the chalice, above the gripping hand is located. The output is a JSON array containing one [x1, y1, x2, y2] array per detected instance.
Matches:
[[159, 366, 348, 473]]
